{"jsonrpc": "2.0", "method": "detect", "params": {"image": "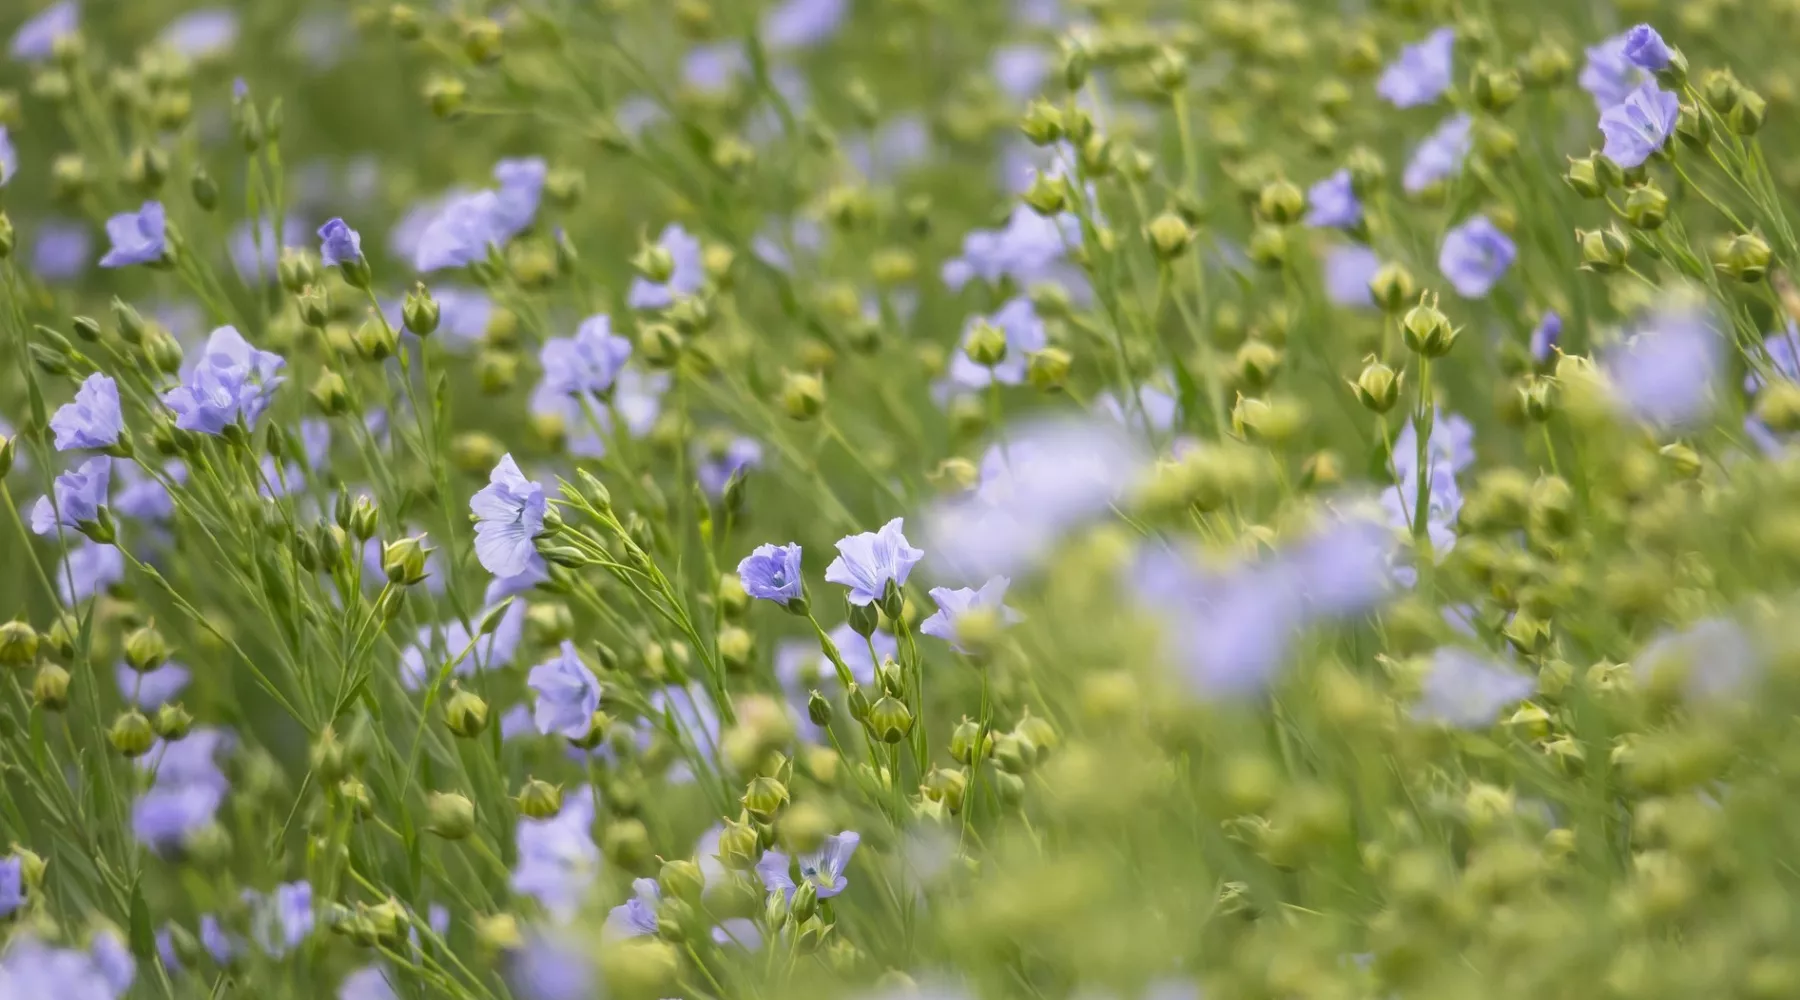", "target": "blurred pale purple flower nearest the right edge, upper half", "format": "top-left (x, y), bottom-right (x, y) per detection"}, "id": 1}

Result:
top-left (1600, 300), bottom-right (1724, 428)
